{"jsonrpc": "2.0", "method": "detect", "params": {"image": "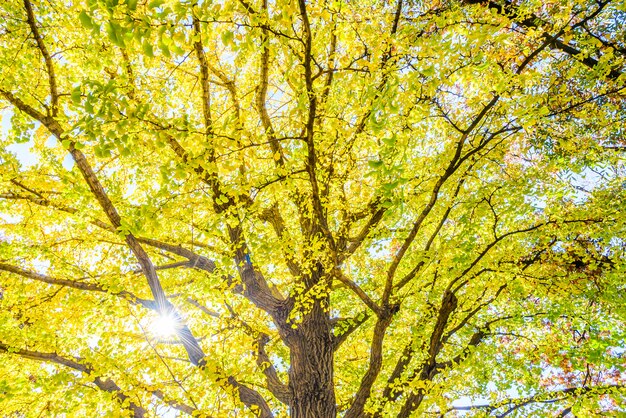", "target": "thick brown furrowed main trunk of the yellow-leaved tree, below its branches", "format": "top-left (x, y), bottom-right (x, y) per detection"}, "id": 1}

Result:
top-left (289, 301), bottom-right (337, 418)
